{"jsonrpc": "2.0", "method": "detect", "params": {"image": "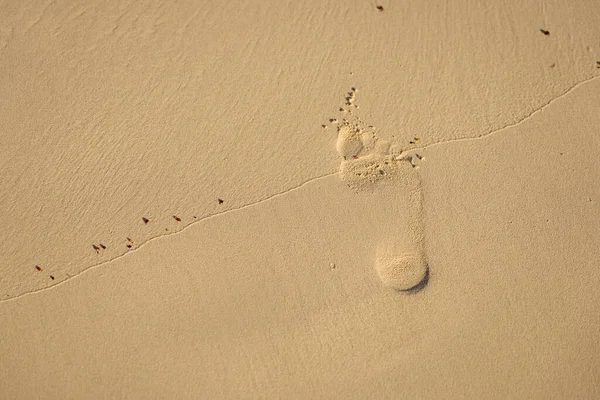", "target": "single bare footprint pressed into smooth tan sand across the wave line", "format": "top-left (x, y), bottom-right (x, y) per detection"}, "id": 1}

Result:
top-left (328, 94), bottom-right (430, 293)
